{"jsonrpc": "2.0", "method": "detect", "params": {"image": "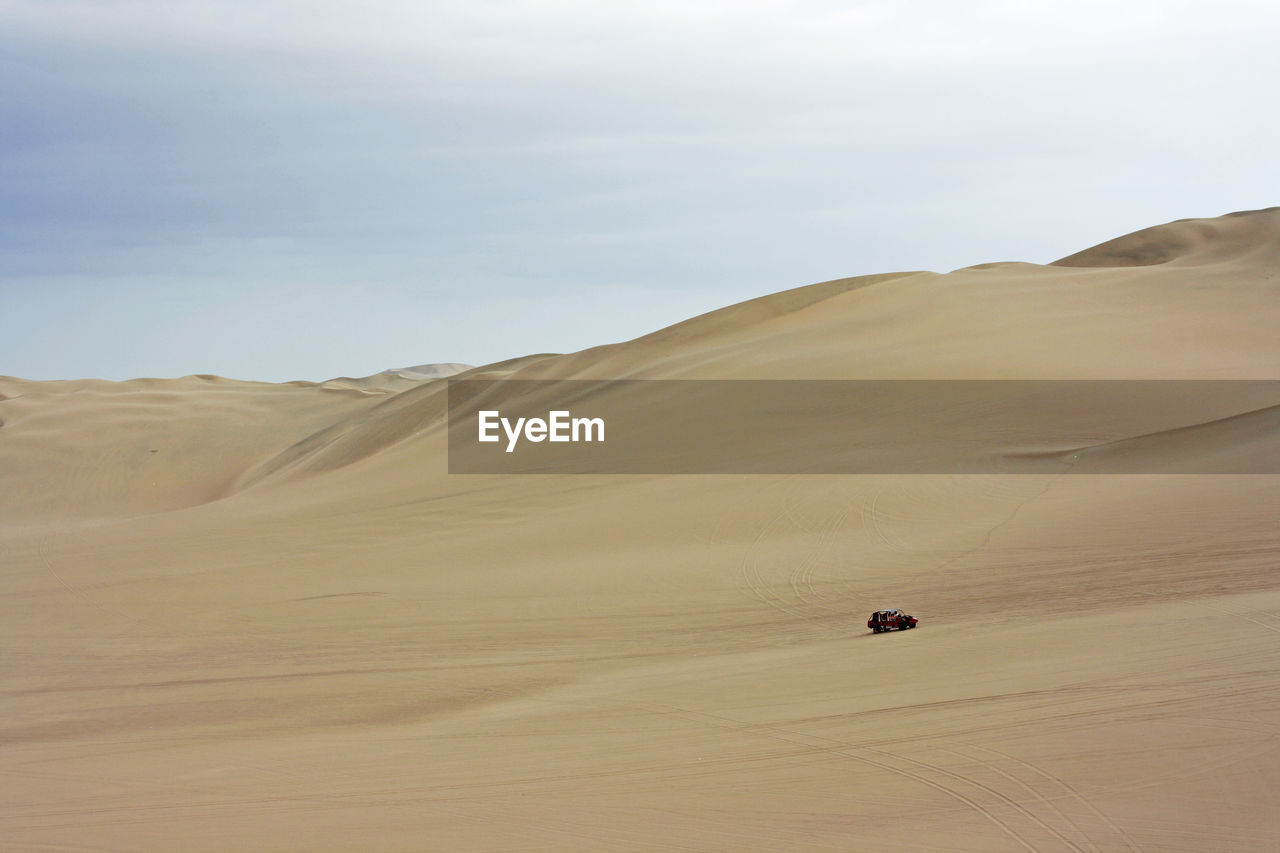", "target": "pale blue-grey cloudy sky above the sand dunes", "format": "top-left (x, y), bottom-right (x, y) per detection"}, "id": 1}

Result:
top-left (0, 0), bottom-right (1280, 382)
